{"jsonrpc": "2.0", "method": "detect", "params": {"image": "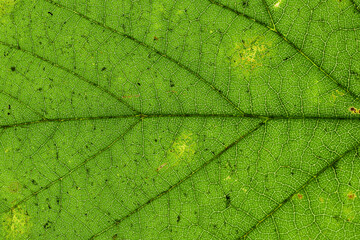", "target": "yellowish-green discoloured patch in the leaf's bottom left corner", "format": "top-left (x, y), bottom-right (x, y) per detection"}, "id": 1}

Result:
top-left (1, 206), bottom-right (31, 240)
